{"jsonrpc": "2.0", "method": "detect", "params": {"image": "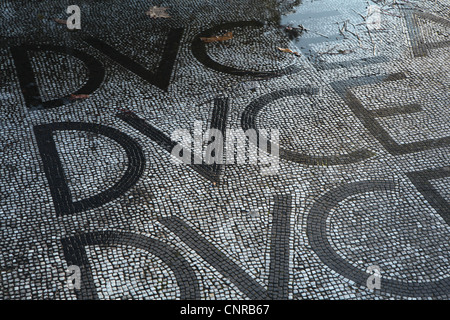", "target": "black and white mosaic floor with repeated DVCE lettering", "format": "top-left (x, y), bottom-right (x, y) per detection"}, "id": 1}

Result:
top-left (0, 0), bottom-right (450, 299)
